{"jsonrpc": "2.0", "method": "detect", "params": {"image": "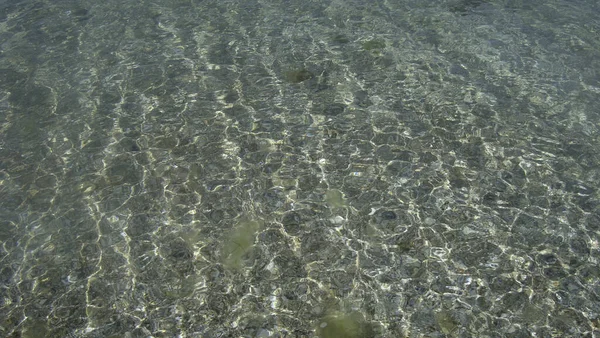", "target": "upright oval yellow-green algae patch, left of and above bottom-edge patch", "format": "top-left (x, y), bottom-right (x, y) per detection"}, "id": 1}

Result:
top-left (221, 220), bottom-right (262, 270)
